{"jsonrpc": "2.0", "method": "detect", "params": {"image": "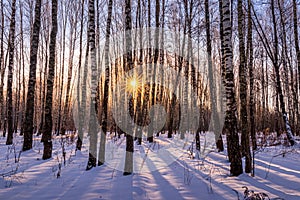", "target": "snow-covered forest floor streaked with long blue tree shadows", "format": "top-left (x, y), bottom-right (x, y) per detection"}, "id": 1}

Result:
top-left (0, 134), bottom-right (300, 200)
